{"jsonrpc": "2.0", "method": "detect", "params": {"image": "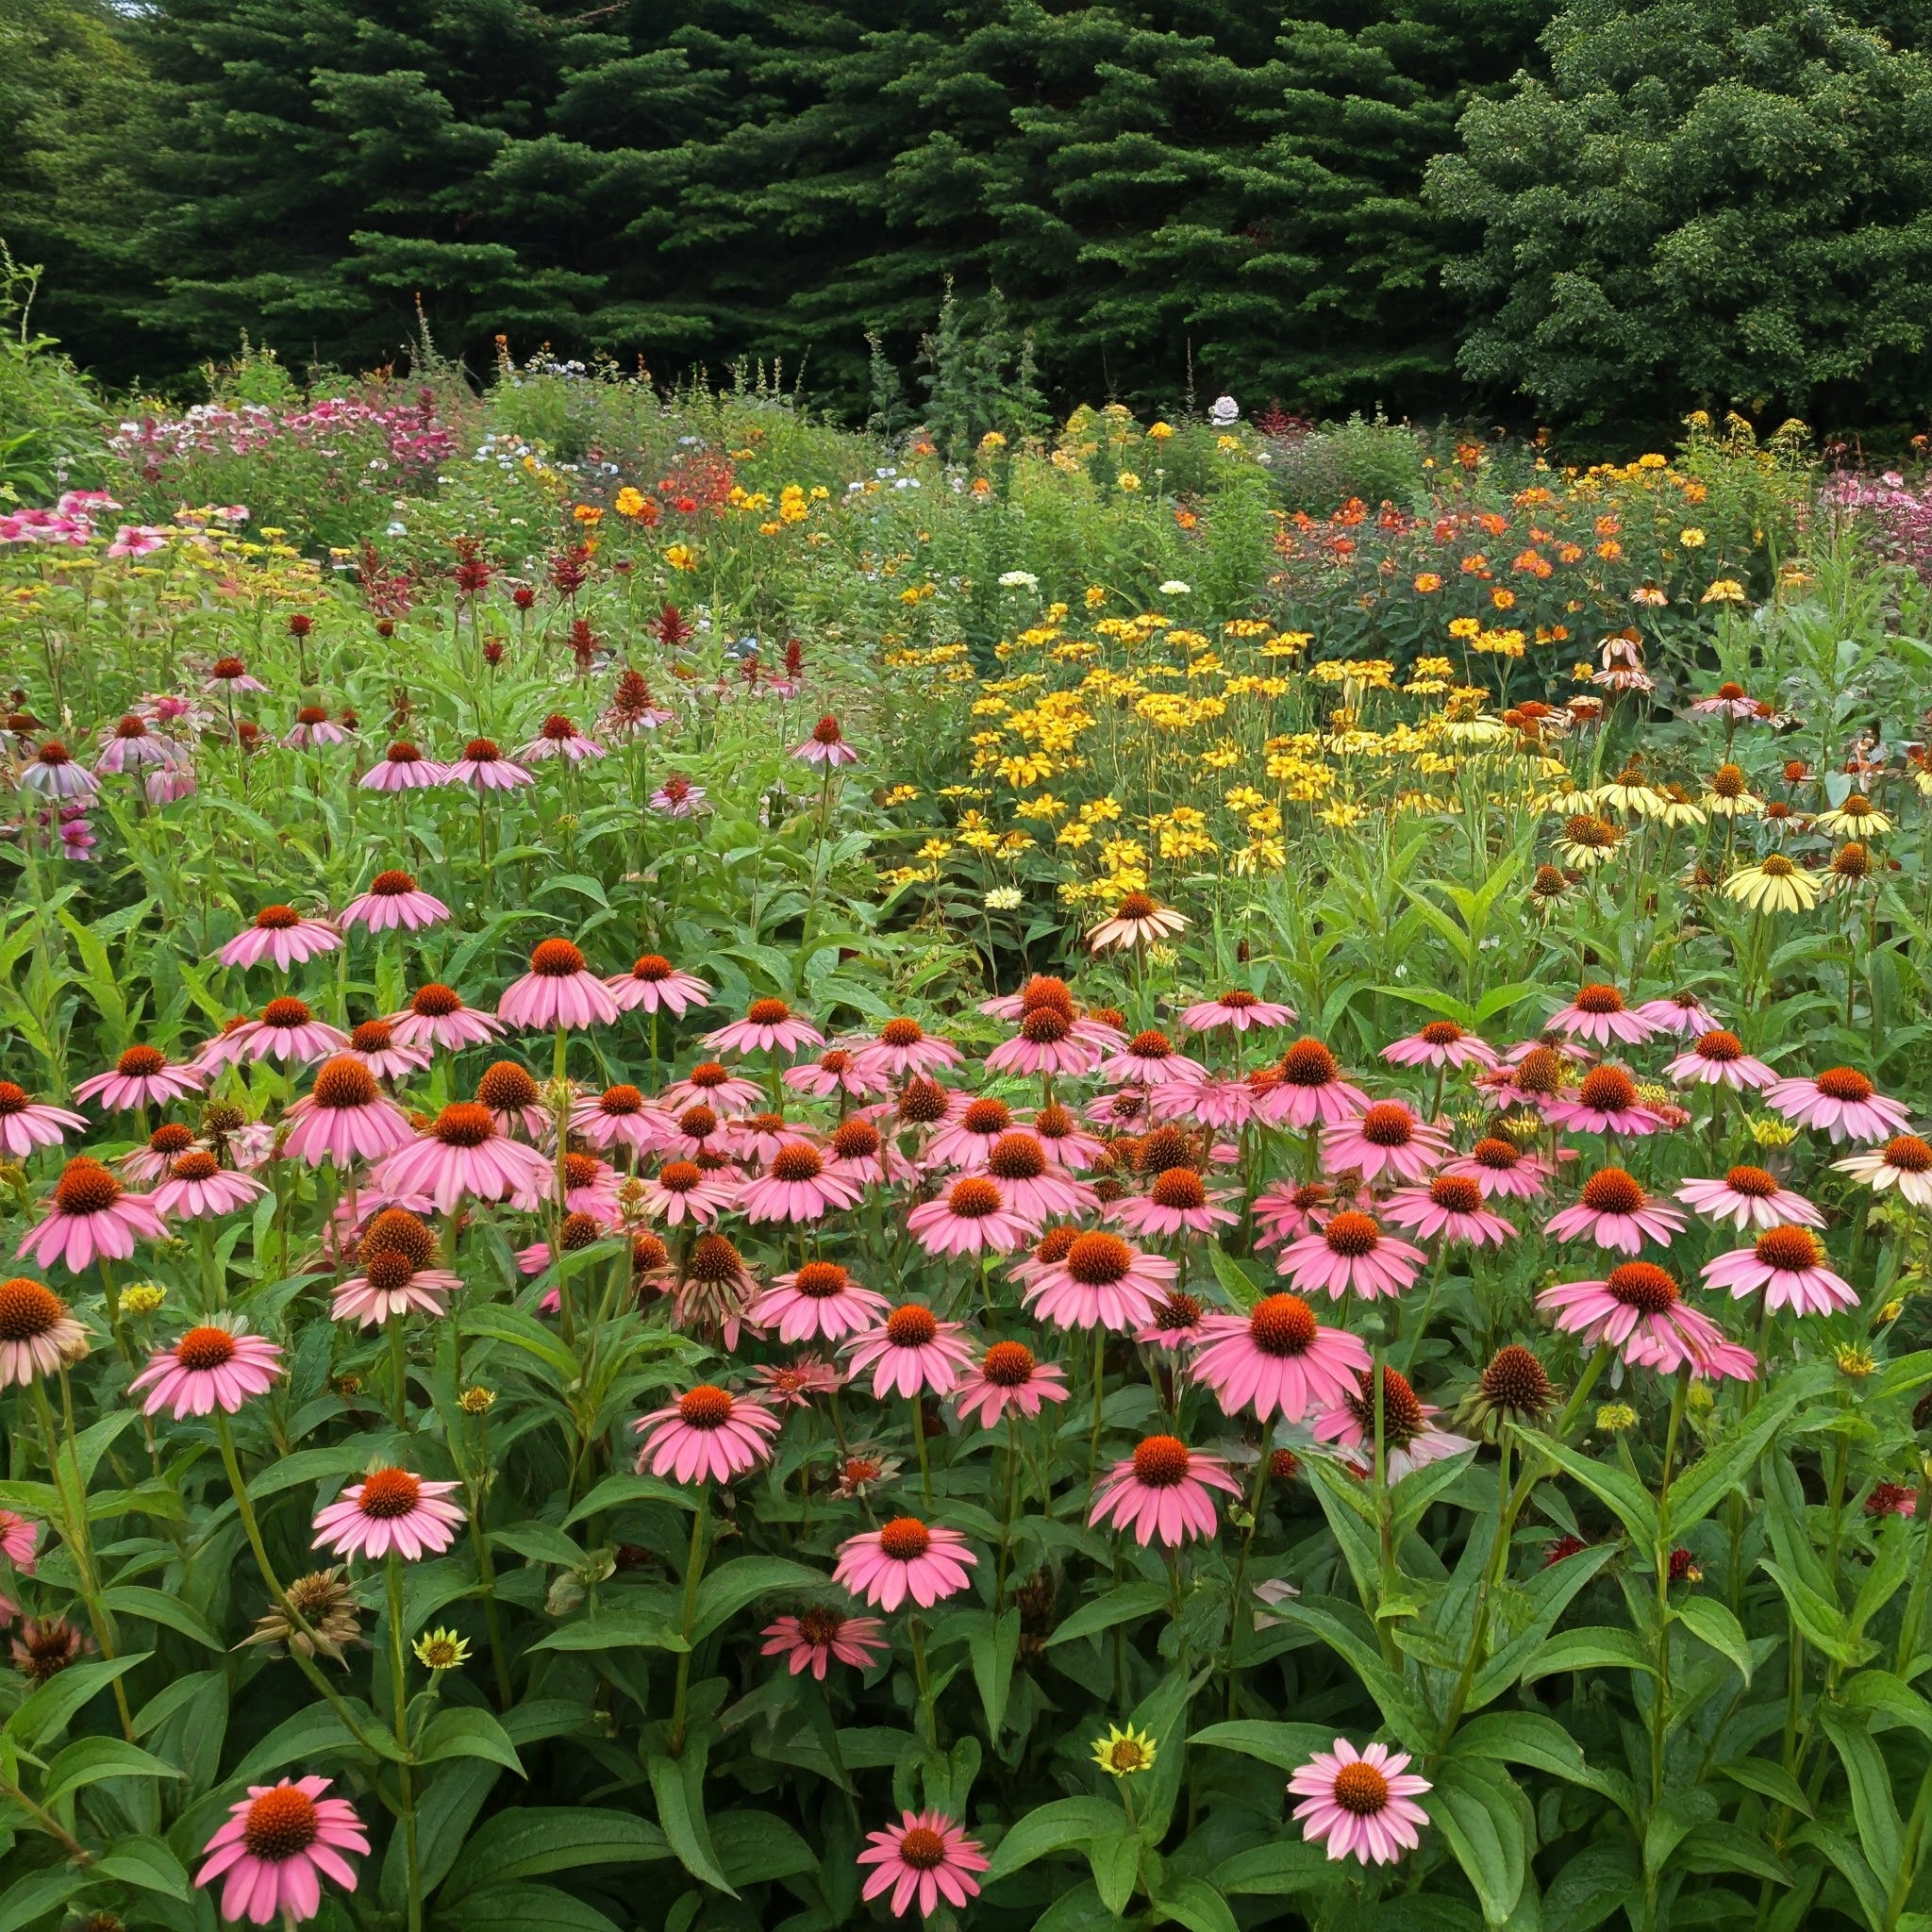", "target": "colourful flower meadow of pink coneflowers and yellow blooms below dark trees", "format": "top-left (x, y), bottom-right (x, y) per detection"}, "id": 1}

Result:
top-left (0, 348), bottom-right (1932, 1932)
